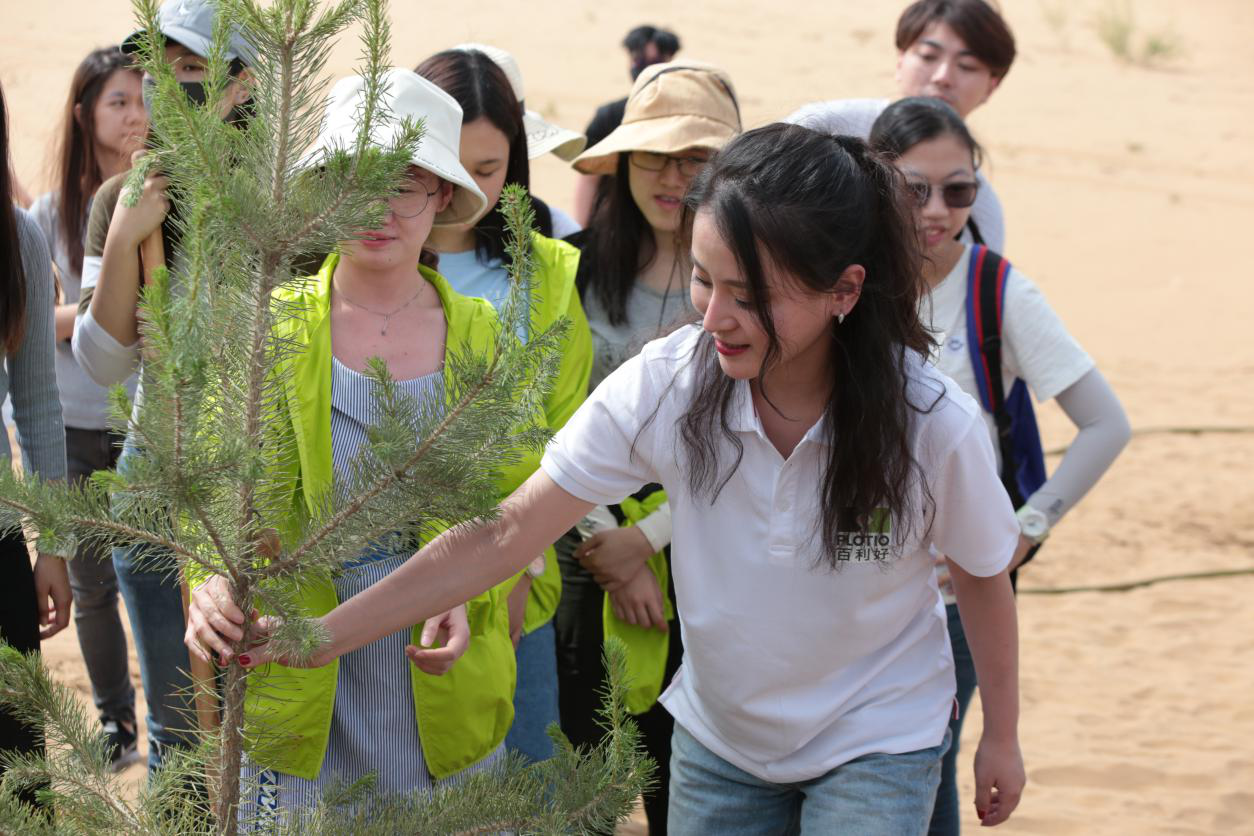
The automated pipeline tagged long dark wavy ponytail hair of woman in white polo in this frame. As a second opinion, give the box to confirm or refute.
[678,124,939,568]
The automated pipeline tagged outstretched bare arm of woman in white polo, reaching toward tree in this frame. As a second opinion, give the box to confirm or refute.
[320,471,592,661]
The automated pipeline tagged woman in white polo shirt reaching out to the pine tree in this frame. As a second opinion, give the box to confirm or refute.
[223,124,1025,836]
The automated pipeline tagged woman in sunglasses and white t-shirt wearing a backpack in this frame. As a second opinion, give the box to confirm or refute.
[870,97,1130,833]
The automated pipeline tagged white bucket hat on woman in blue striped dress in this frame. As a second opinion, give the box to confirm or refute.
[301,66,488,227]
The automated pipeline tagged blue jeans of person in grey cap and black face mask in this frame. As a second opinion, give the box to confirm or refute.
[113,446,196,770]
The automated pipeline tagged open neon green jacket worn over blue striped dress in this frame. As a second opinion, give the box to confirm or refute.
[246,254,514,780]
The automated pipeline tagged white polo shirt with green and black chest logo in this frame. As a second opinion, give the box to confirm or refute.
[540,326,1018,782]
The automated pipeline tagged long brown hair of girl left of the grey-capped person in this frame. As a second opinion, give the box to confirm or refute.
[54,46,139,272]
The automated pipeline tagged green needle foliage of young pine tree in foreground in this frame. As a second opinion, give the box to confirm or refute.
[0,0,651,835]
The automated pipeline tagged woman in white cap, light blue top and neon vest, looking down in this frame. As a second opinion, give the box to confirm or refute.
[418,45,592,761]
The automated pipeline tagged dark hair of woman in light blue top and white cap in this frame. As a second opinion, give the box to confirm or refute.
[414,49,553,262]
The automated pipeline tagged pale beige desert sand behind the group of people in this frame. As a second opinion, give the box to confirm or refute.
[0,0,1254,836]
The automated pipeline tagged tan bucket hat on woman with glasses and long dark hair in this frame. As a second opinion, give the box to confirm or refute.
[574,61,740,174]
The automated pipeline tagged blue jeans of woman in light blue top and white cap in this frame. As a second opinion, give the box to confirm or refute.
[505,620,558,761]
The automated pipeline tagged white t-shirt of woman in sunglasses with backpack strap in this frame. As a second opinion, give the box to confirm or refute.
[919,247,1093,468]
